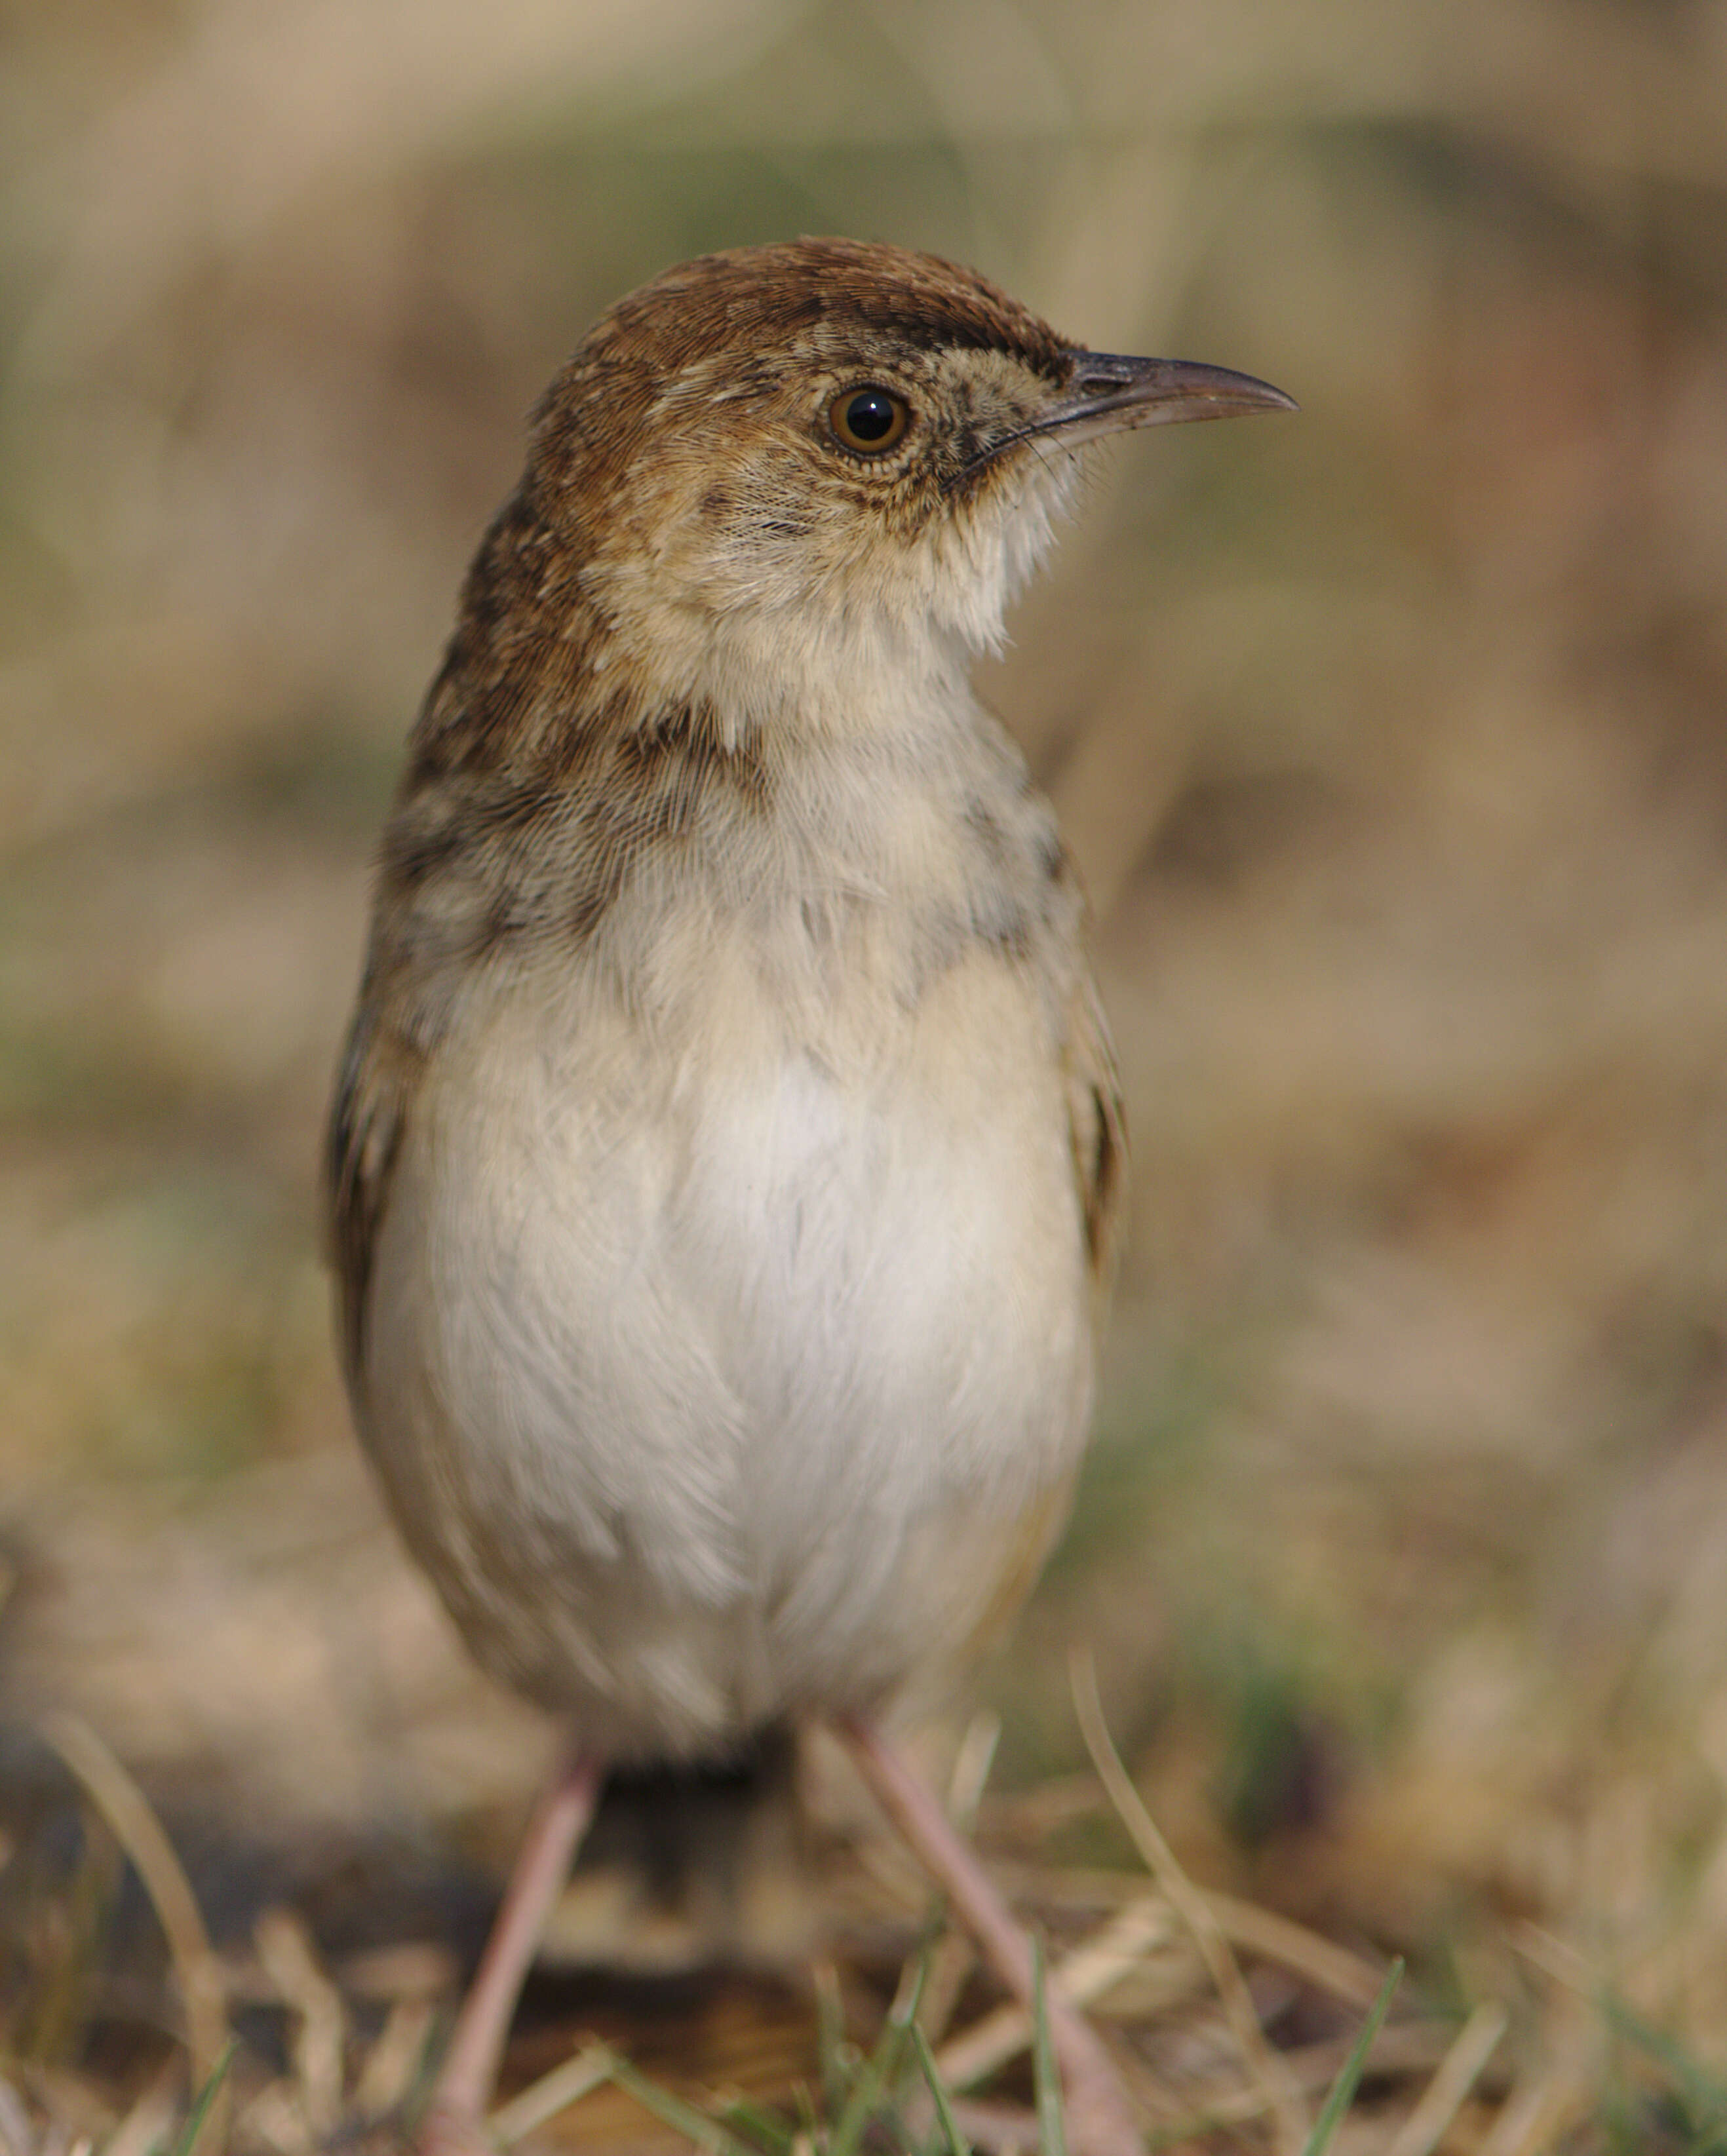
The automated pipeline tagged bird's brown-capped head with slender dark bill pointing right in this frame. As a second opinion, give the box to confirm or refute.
[472,239,1291,737]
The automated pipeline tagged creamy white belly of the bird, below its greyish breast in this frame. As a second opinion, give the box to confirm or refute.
[358,955,1091,1757]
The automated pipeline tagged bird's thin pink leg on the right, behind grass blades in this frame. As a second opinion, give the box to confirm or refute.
[839,1716,1145,2156]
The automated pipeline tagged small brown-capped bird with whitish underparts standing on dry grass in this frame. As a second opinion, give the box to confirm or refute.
[326,239,1294,2156]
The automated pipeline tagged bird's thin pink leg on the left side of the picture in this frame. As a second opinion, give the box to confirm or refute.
[416,1753,604,2156]
